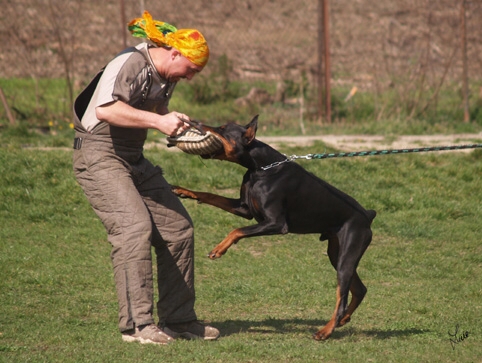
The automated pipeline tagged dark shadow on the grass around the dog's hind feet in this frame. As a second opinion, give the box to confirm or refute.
[211,318,428,340]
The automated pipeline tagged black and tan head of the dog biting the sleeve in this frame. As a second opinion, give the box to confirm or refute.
[194,115,258,164]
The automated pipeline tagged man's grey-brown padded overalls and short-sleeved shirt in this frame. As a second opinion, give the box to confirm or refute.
[73,46,196,332]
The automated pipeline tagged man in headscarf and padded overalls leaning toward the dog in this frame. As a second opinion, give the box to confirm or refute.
[73,12,219,344]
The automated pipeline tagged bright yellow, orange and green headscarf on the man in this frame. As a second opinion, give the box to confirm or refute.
[127,11,209,67]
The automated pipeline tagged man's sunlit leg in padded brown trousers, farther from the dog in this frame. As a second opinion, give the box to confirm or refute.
[74,147,154,331]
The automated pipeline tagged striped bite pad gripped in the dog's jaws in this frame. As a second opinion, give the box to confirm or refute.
[167,128,223,158]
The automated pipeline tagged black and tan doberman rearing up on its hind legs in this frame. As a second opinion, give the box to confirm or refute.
[172,116,376,340]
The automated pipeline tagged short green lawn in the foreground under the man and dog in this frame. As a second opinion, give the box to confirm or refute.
[0,130,482,363]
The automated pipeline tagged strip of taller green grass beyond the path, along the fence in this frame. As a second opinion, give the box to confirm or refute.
[0,77,482,135]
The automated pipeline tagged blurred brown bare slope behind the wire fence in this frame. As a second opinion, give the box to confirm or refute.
[0,0,482,121]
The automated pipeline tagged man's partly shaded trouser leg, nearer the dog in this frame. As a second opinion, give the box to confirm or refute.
[134,164,196,326]
